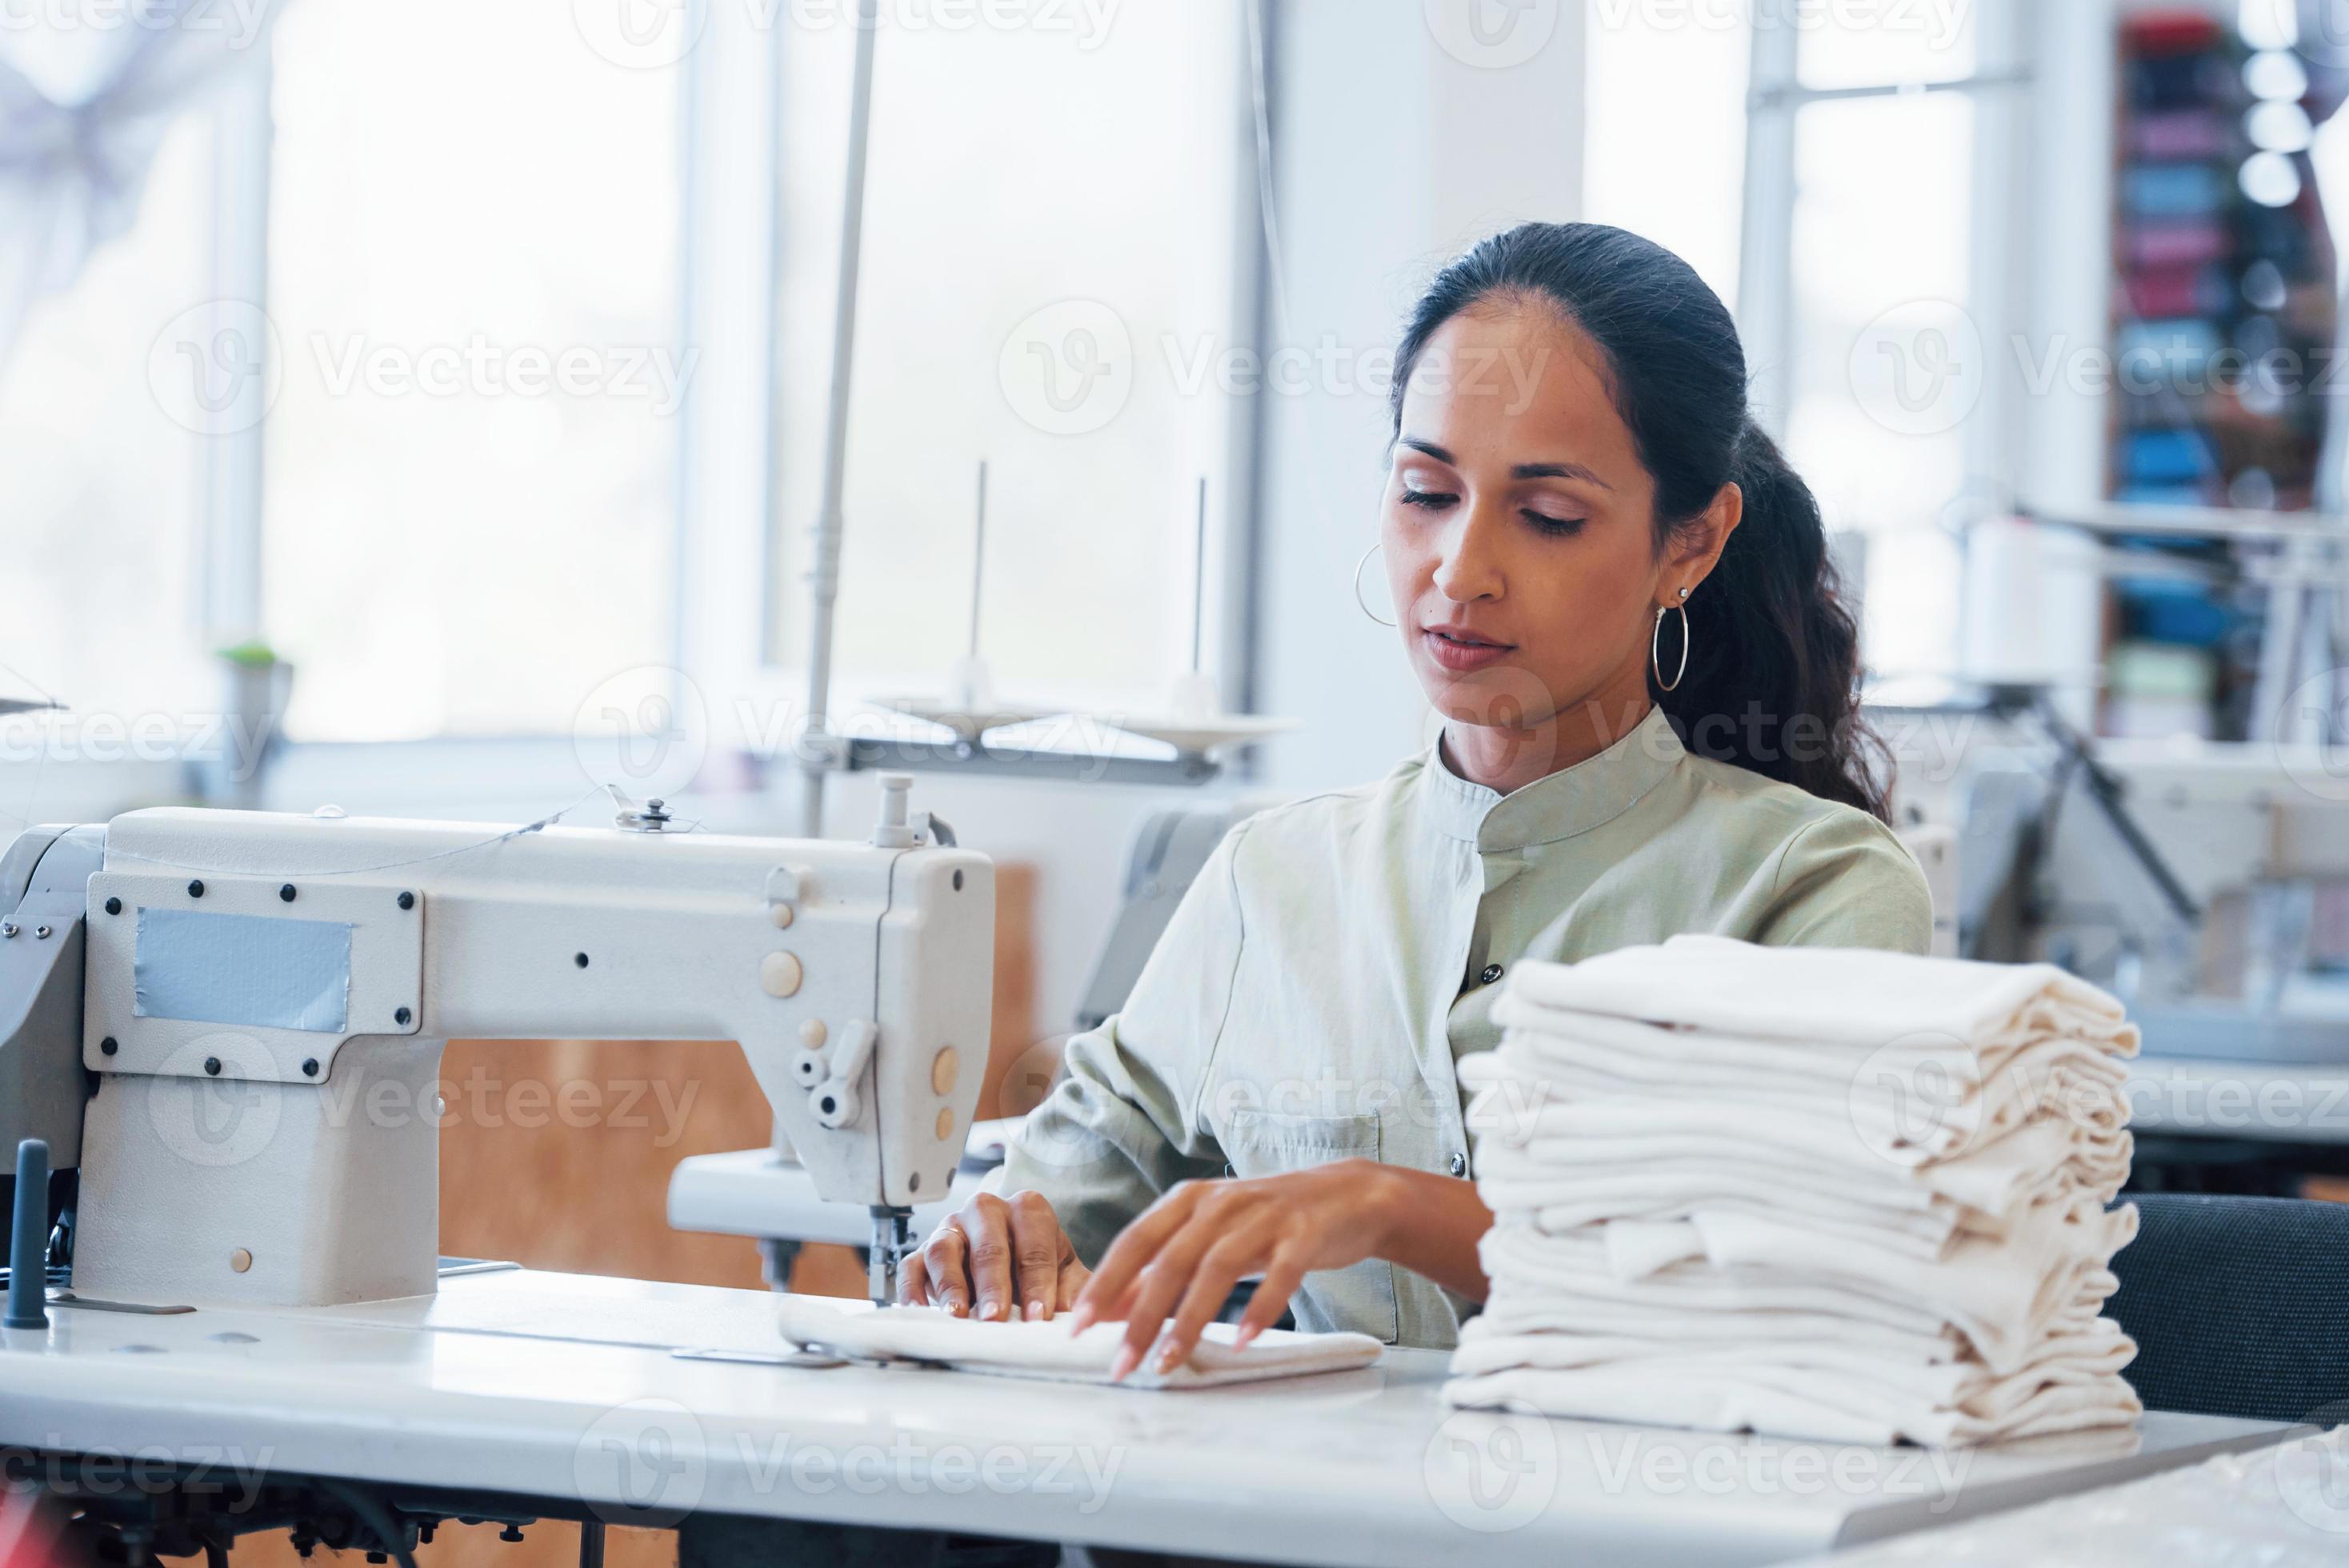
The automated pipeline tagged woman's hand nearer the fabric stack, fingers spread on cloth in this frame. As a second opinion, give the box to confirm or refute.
[1071,1159,1395,1382]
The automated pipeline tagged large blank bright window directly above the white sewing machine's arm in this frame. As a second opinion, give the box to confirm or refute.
[263,0,693,739]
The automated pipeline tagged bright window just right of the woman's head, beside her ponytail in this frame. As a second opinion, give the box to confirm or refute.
[1741,7,2018,674]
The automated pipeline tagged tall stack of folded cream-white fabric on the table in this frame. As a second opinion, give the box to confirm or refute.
[1445,937,2140,1443]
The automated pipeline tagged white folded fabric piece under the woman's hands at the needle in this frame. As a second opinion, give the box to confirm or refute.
[775,1296,1383,1390]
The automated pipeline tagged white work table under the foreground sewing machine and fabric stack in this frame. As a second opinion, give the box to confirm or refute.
[0,1270,2281,1566]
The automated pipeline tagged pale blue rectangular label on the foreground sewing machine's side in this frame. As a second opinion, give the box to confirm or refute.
[134,909,350,1033]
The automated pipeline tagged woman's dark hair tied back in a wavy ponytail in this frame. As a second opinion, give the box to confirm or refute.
[1391,223,1889,819]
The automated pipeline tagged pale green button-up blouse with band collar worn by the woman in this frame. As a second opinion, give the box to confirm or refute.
[989,711,1933,1347]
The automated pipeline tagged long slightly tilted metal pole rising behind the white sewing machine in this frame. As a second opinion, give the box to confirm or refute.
[801,0,881,838]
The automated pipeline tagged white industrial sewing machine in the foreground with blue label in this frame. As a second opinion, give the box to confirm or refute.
[0,774,994,1307]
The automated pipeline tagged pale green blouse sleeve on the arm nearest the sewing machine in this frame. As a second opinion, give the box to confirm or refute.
[986,822,1247,1263]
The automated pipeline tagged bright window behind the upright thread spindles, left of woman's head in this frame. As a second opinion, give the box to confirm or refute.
[770,0,1252,716]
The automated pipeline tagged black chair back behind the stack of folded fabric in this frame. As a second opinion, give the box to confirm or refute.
[2105,1193,2349,1425]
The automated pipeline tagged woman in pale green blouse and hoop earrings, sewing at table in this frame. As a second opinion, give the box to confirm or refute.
[904,223,1931,1378]
